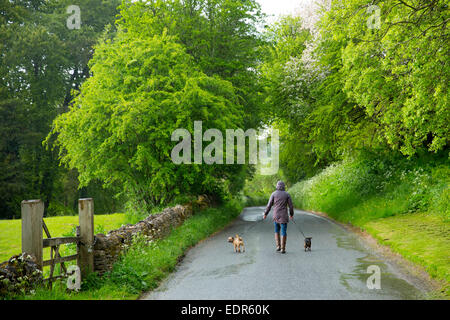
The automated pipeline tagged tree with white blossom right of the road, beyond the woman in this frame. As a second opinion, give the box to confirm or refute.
[260,16,328,183]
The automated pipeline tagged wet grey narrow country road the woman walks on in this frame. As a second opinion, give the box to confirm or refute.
[143,207,423,300]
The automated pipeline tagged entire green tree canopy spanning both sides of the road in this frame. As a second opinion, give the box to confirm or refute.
[0,0,450,217]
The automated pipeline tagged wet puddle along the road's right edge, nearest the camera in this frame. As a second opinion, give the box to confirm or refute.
[335,235,424,300]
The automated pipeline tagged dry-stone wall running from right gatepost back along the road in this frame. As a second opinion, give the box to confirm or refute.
[94,196,210,274]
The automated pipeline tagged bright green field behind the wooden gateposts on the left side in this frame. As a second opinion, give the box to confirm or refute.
[0,214,125,262]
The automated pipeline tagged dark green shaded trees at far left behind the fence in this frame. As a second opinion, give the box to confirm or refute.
[0,0,120,217]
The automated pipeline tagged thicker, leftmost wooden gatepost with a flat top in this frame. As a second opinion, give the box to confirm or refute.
[21,200,44,270]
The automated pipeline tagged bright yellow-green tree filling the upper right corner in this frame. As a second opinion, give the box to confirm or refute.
[320,0,450,156]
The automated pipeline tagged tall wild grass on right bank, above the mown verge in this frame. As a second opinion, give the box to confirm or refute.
[289,156,450,225]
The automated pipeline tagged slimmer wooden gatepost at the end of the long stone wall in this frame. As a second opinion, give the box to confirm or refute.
[78,198,94,277]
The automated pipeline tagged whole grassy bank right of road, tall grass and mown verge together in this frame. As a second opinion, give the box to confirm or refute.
[289,157,450,296]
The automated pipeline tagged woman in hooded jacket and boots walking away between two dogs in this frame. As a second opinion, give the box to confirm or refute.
[264,181,294,253]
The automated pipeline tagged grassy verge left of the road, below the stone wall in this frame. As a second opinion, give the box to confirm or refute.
[7,201,243,300]
